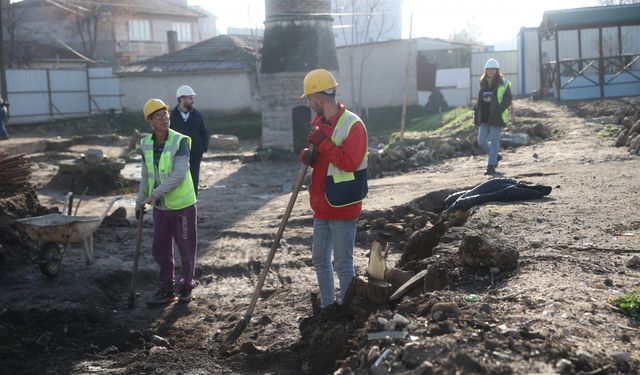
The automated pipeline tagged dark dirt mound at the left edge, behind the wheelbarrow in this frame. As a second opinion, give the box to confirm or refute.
[0,185,57,269]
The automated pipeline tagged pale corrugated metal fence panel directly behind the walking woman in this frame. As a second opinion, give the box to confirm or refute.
[471,50,520,99]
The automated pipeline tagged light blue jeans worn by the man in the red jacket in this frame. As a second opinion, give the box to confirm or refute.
[312,219,357,307]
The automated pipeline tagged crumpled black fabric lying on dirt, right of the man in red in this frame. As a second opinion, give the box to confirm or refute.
[444,178,551,210]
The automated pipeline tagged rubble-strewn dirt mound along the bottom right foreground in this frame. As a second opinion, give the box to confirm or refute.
[335,292,632,374]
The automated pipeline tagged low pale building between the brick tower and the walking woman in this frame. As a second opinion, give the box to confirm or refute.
[338,38,484,109]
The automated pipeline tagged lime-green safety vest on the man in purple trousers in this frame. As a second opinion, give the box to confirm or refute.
[140,129,196,210]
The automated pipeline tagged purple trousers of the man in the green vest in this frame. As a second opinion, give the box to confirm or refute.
[152,204,198,292]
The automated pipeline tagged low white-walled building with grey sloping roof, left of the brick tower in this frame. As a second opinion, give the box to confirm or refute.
[118,35,261,112]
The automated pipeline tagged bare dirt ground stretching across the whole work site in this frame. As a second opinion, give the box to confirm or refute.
[0,100,640,374]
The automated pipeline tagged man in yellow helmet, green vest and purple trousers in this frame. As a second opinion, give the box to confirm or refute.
[135,99,198,305]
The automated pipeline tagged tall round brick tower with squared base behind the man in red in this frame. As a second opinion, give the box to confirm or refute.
[259,0,338,150]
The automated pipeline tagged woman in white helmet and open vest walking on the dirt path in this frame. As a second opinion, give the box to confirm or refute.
[474,58,512,175]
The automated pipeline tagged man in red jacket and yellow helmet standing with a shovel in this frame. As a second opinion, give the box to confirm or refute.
[300,69,368,307]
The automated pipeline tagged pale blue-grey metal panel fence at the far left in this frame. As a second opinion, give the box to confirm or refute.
[6,68,122,122]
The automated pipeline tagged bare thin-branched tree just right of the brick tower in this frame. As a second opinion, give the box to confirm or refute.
[334,0,396,113]
